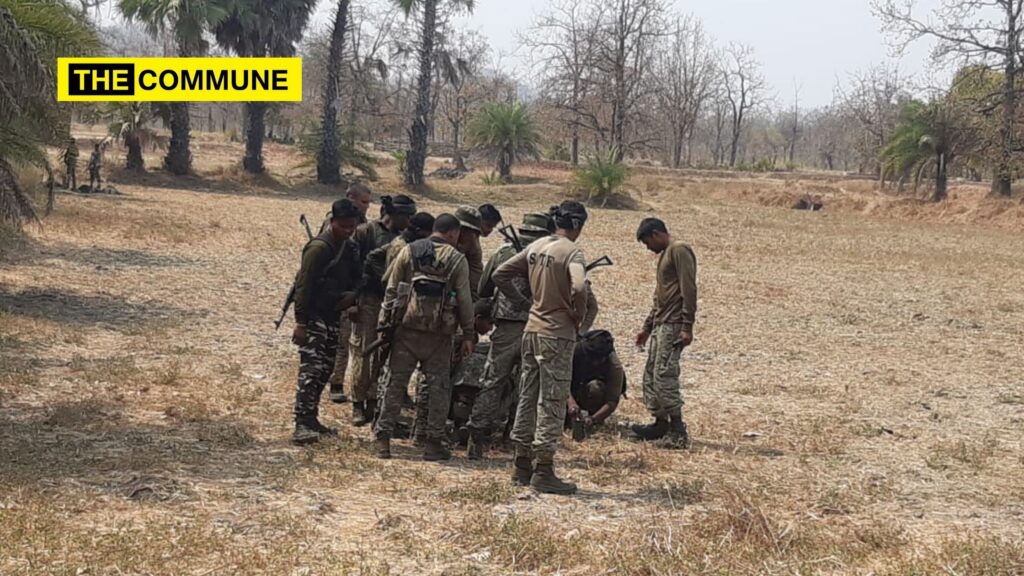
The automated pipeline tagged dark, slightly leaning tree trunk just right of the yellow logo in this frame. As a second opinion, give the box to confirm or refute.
[316,0,349,186]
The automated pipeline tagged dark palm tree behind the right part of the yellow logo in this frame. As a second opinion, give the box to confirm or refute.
[213,0,316,174]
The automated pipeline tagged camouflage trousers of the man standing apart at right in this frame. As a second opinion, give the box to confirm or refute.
[643,324,683,418]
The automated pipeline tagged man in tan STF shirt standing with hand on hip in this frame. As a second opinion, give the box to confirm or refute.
[494,200,589,494]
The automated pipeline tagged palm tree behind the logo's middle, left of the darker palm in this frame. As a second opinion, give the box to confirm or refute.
[118,0,230,175]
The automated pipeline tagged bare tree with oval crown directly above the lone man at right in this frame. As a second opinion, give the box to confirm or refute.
[652,15,718,168]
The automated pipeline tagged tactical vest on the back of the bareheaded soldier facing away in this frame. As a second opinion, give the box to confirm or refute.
[401,239,466,336]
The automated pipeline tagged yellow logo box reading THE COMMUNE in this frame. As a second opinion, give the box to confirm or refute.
[57,57,302,102]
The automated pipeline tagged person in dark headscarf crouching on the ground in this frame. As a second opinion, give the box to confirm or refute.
[565,330,626,430]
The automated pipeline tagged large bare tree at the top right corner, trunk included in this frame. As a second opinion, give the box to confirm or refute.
[873,0,1024,196]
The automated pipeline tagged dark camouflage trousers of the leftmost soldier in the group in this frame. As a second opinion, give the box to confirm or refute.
[295,320,338,422]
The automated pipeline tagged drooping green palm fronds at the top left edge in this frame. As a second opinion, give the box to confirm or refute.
[0,0,100,227]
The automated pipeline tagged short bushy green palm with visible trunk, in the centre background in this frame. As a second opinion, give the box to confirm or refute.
[466,102,541,182]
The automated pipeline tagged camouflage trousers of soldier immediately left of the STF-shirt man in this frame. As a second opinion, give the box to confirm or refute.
[469,320,526,435]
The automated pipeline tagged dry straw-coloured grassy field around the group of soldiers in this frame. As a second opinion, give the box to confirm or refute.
[0,132,1024,576]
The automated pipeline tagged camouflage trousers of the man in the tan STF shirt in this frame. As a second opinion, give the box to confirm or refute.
[512,332,575,452]
